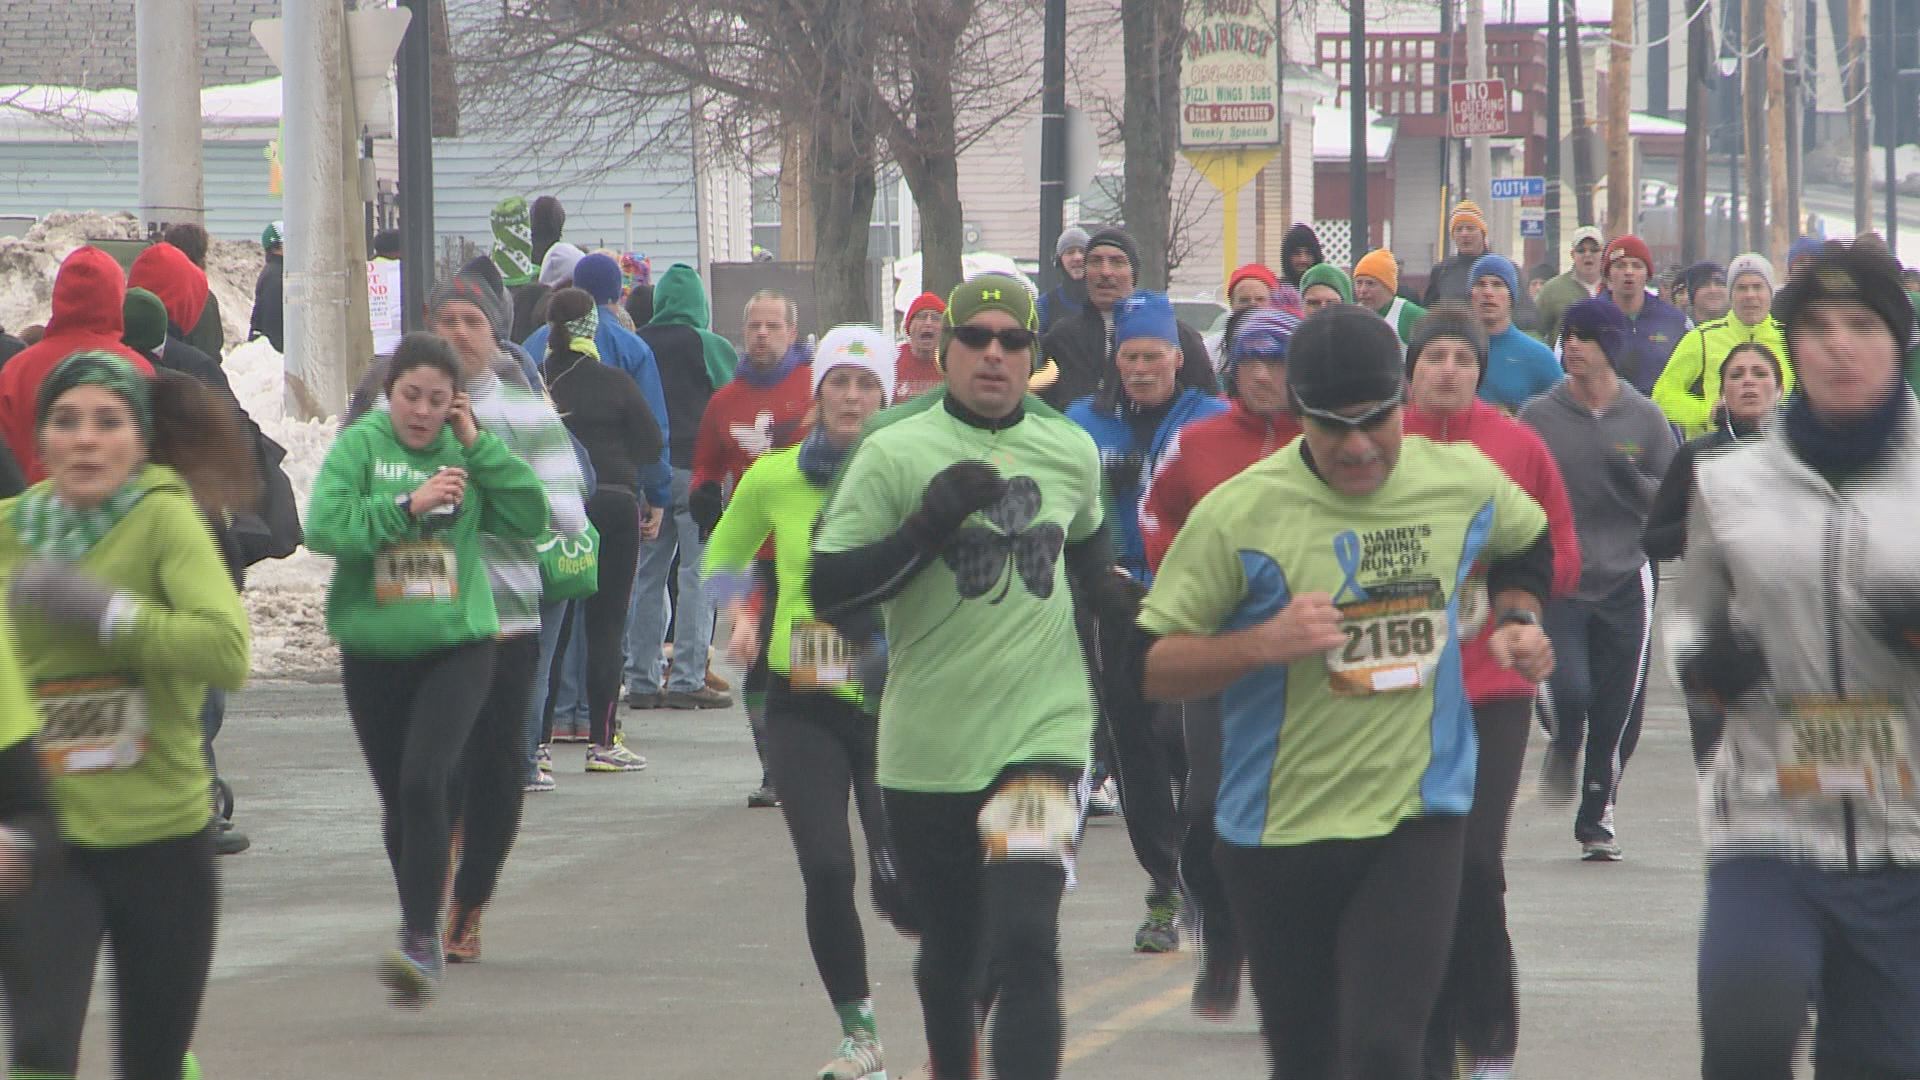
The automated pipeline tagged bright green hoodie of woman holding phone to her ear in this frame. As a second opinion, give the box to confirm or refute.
[307,409,547,659]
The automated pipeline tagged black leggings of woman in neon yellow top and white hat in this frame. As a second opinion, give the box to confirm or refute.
[766,673,900,1005]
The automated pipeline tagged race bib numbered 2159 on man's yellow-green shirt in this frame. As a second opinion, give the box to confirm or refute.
[1327,580,1450,698]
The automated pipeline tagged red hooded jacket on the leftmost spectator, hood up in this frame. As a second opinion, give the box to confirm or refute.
[0,248,153,484]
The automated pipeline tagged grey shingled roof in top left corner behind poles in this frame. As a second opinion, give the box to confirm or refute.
[0,0,280,90]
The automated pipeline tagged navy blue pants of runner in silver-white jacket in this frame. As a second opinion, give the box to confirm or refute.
[1699,857,1920,1080]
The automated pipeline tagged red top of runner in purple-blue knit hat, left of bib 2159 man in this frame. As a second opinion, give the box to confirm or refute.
[1140,400,1300,575]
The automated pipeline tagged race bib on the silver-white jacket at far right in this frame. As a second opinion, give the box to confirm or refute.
[1778,696,1914,803]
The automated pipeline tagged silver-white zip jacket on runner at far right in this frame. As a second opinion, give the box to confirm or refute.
[1667,386,1920,872]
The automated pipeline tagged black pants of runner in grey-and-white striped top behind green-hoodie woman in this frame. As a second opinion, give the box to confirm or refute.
[453,634,540,911]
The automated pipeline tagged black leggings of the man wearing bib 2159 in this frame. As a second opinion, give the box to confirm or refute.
[1217,817,1467,1080]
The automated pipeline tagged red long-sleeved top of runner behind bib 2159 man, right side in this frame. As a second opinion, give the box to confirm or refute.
[1405,398,1580,705]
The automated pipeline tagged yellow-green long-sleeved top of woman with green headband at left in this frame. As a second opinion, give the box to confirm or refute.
[0,465,248,847]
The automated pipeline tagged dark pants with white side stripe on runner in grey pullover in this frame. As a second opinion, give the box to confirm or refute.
[1544,565,1653,844]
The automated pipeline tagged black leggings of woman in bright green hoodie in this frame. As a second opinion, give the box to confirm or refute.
[340,642,495,936]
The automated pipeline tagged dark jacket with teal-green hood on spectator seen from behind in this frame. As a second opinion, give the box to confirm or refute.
[639,263,739,469]
